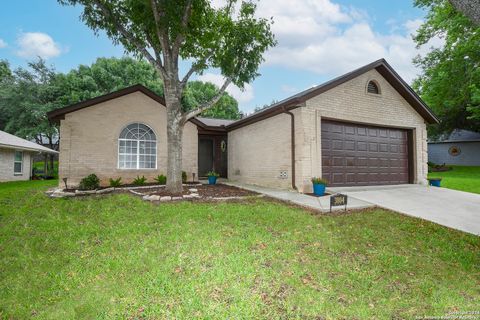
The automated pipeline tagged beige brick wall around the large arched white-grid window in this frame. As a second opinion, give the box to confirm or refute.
[59,92,198,186]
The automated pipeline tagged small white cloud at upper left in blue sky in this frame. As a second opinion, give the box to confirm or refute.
[17,32,62,59]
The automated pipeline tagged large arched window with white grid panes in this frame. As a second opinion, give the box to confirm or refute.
[118,123,157,169]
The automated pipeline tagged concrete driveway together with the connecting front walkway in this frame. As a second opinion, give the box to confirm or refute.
[226,181,480,235]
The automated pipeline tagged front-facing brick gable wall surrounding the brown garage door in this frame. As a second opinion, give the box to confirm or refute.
[296,70,428,192]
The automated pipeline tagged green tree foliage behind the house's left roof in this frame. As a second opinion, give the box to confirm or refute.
[0,57,241,149]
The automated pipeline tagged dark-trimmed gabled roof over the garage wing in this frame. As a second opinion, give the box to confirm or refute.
[227,59,439,130]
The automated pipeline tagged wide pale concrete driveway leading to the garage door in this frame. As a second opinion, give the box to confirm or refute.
[329,185,480,235]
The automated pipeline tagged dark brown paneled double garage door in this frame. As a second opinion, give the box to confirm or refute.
[322,120,409,186]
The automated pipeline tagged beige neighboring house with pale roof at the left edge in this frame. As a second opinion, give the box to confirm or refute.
[0,131,58,182]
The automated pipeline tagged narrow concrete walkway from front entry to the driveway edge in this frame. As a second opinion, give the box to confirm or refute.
[222,181,375,212]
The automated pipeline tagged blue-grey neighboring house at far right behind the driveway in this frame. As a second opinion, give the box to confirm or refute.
[428,129,480,166]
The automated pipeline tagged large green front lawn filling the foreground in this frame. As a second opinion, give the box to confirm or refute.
[0,181,480,319]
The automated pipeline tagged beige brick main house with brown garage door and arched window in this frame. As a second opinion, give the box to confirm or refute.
[49,59,438,192]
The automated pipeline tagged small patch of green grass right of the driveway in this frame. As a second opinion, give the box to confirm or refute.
[428,166,480,193]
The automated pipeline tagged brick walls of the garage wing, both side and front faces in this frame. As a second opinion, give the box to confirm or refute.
[228,70,428,192]
